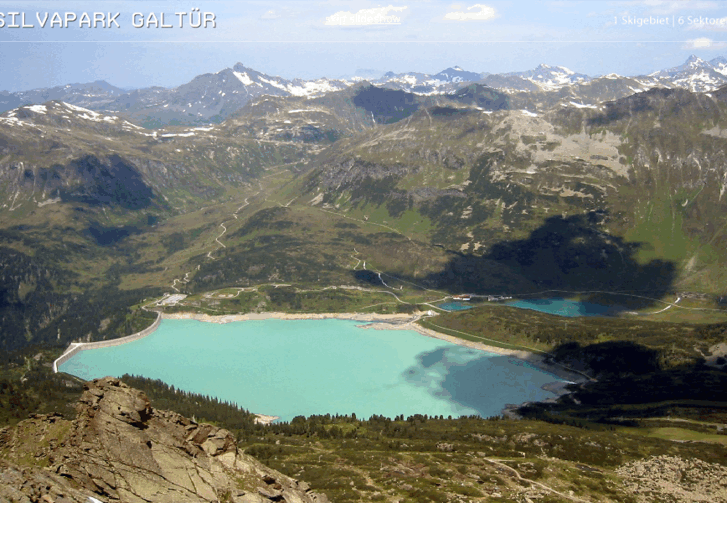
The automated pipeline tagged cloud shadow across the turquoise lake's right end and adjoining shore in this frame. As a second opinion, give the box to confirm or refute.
[402,342,727,422]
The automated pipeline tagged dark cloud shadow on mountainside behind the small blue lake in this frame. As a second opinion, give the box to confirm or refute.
[352,212,677,309]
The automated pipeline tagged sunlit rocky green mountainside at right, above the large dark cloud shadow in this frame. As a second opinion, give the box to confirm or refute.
[280,93,727,302]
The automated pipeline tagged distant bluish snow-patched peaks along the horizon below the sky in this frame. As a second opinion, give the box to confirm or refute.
[0,55,727,128]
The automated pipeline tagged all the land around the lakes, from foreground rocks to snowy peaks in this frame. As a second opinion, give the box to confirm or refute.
[0,56,727,501]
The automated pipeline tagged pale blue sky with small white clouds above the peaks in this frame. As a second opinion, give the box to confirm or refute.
[0,0,727,91]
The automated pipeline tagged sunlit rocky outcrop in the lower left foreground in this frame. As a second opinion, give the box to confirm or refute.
[0,377,326,503]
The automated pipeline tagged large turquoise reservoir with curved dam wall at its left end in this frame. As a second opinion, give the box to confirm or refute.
[60,320,559,421]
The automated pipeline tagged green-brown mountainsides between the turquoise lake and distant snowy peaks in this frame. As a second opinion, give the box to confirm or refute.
[0,72,727,348]
